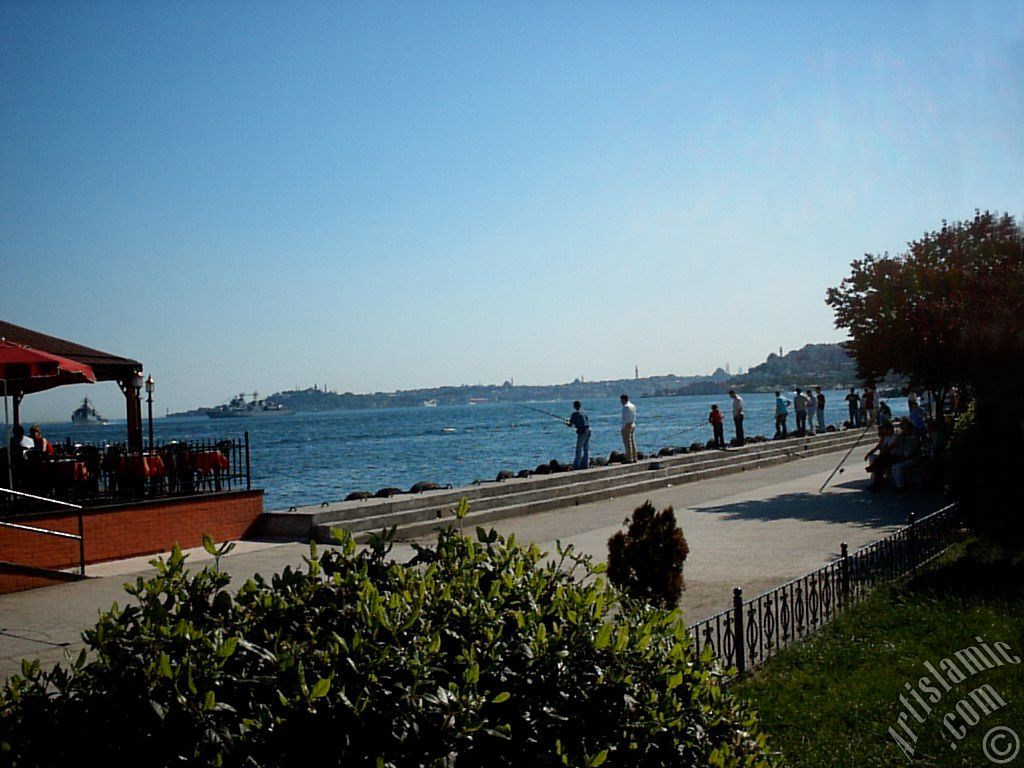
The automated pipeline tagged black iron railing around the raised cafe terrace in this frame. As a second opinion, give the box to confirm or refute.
[0,432,252,516]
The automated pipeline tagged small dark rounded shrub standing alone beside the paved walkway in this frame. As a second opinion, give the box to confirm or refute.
[608,501,690,609]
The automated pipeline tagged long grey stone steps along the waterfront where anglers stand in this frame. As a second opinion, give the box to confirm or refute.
[310,431,860,542]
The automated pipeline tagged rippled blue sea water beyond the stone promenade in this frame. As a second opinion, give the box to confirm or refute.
[43,391,906,510]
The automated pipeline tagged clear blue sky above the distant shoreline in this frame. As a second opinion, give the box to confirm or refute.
[0,0,1024,420]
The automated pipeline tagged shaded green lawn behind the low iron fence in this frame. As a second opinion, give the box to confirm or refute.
[734,540,1024,768]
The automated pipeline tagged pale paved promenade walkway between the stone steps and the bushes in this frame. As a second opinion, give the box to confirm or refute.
[0,447,941,679]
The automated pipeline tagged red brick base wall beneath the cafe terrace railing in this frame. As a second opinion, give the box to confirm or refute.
[0,490,263,593]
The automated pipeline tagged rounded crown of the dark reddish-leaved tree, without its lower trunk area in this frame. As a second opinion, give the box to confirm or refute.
[826,211,1024,411]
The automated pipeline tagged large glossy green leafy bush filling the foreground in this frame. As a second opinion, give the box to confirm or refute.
[0,507,776,768]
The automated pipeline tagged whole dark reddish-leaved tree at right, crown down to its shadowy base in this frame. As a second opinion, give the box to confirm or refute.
[826,211,1024,544]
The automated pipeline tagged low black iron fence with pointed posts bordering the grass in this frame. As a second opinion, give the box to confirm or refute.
[689,504,959,674]
